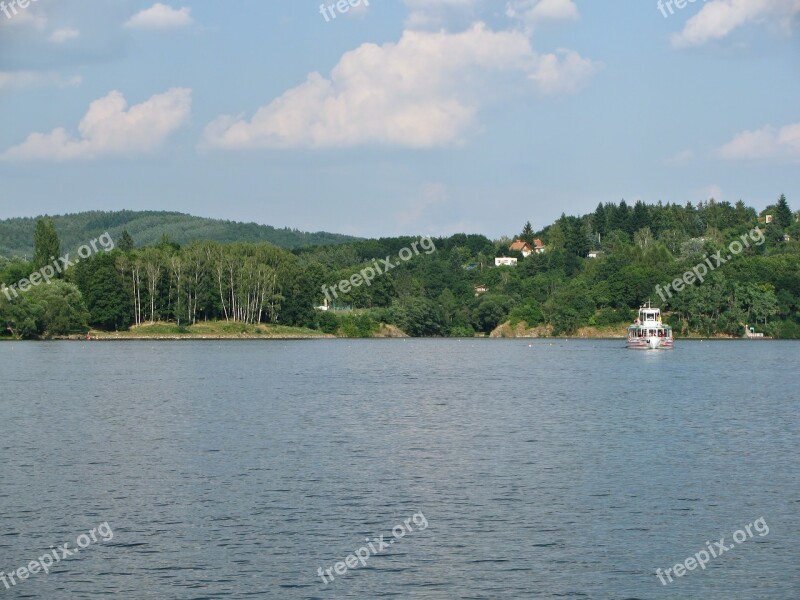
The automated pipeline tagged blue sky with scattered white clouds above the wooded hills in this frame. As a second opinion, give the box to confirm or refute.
[0,0,800,238]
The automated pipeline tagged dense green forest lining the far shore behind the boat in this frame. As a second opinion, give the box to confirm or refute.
[0,196,800,338]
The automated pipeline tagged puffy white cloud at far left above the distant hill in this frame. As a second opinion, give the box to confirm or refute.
[0,88,192,161]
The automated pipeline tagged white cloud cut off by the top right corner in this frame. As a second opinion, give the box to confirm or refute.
[672,0,800,48]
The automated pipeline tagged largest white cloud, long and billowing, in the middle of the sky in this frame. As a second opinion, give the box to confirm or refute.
[205,23,597,149]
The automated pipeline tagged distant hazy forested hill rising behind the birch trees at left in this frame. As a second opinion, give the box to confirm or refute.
[0,210,357,257]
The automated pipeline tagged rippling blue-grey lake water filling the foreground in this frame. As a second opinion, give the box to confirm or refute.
[0,340,800,600]
